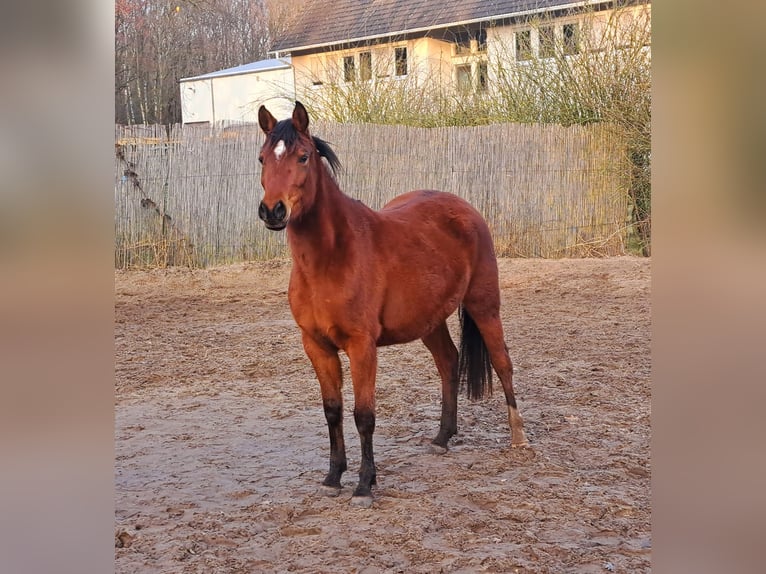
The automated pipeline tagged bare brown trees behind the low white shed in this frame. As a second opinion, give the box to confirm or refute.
[115,0,296,124]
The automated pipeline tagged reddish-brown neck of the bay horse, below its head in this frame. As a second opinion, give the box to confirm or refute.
[288,174,373,262]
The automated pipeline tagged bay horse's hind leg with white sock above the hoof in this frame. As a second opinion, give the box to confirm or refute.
[463,302,529,447]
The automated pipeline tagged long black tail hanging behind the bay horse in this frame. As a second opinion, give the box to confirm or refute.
[458,306,492,400]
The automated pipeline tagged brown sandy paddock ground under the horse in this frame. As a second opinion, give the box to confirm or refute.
[115,257,651,574]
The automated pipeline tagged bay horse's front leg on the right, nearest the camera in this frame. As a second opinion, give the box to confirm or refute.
[346,338,378,508]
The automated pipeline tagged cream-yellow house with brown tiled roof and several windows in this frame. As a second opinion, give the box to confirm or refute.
[271,0,651,115]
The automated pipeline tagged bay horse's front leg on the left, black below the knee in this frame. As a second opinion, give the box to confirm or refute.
[303,333,347,496]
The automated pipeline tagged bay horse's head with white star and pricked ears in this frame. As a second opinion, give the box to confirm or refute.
[258,102,339,231]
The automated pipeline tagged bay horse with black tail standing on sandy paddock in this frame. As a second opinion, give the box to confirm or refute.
[258,102,528,507]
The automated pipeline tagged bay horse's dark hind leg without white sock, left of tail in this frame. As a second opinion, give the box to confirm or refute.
[422,322,458,453]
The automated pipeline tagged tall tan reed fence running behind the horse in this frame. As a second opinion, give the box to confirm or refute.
[115,121,631,268]
